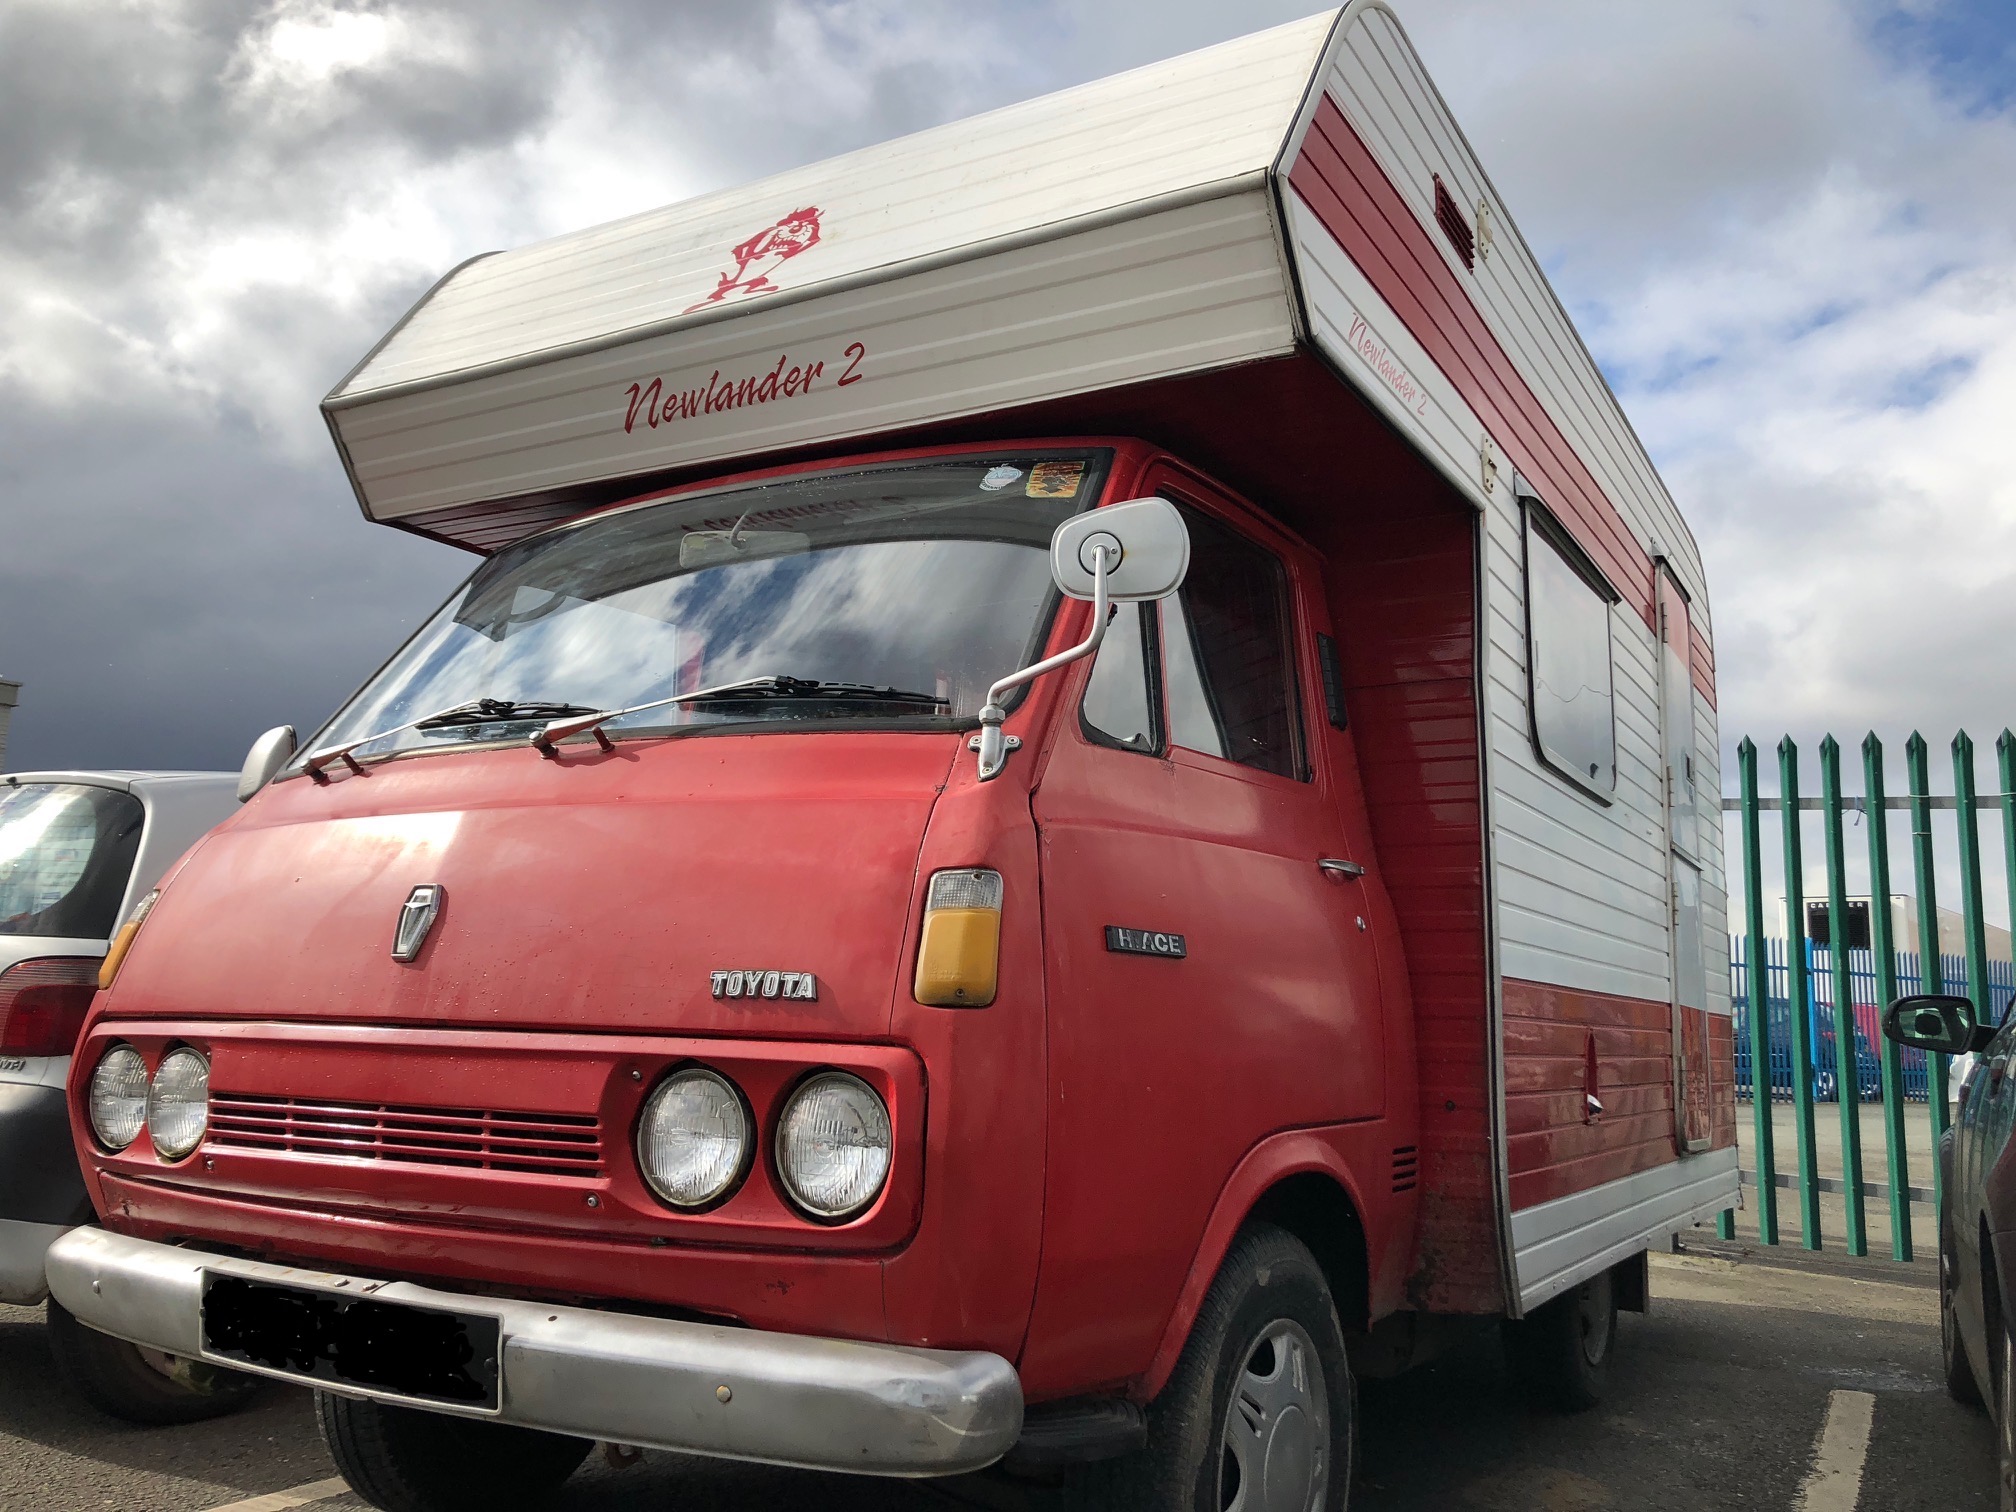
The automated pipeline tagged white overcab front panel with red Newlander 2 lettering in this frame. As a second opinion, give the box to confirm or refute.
[333,195,1294,520]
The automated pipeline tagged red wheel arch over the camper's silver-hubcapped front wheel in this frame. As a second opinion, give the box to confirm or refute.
[1139,1129,1371,1401]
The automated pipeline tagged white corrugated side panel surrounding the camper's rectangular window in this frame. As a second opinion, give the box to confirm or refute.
[1484,488,1671,1002]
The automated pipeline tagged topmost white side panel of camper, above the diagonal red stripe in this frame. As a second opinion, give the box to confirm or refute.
[1329,6,1708,608]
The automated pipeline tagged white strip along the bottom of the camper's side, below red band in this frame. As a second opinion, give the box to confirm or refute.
[1512,1149,1738,1312]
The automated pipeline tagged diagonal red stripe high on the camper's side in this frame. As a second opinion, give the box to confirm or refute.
[1288,95,1653,625]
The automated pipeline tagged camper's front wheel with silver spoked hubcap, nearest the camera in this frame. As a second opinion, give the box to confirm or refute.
[1079,1224,1357,1512]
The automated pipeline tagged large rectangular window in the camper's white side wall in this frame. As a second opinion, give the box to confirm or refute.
[1526,510,1617,796]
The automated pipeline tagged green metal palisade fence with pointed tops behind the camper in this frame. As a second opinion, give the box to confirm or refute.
[1720,730,2016,1260]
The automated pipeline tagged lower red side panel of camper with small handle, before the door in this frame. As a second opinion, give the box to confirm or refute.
[1504,978,1677,1212]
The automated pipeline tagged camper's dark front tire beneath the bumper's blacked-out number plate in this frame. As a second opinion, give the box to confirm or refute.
[314,1391,595,1512]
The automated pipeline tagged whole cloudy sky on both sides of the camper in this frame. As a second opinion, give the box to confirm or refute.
[0,0,2016,842]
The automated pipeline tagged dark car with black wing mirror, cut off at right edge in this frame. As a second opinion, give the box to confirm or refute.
[1883,996,2016,1512]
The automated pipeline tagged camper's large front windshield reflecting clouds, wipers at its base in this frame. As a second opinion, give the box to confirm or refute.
[304,450,1105,758]
